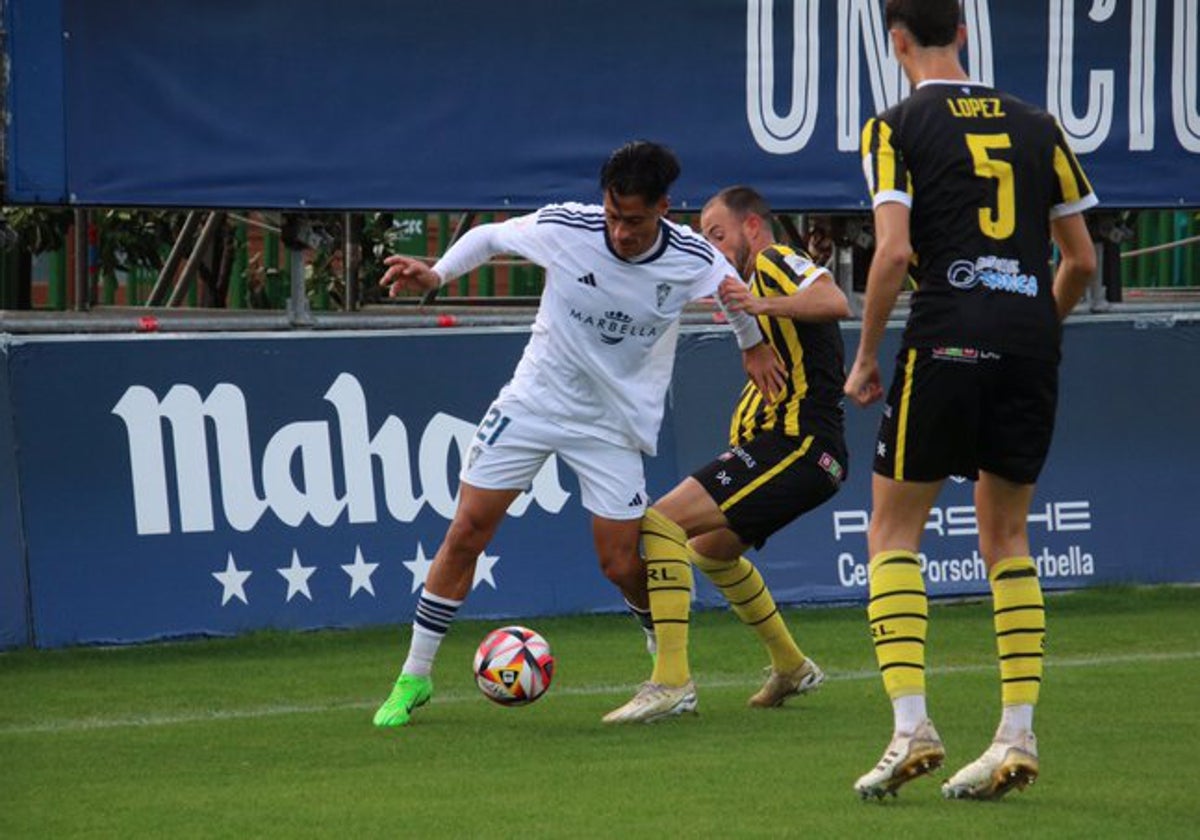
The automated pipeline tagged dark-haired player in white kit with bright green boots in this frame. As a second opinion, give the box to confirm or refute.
[374,140,784,726]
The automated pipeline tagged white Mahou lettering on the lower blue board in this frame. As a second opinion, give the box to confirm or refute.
[112,372,570,535]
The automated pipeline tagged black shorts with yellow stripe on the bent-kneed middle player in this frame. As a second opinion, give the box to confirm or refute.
[692,431,848,548]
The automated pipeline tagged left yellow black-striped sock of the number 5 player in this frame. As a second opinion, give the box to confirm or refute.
[866,551,929,700]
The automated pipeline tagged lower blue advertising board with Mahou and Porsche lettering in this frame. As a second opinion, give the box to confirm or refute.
[0,319,1200,647]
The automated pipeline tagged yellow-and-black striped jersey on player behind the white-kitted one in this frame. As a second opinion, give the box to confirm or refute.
[730,245,846,446]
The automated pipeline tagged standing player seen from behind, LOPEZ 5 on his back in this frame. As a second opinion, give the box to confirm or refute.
[845,0,1097,799]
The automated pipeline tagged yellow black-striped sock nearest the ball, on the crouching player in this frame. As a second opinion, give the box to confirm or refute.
[642,508,691,685]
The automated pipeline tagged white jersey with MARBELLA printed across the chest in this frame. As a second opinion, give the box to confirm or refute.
[433,203,761,455]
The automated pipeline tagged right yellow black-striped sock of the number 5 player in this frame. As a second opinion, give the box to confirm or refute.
[988,557,1046,706]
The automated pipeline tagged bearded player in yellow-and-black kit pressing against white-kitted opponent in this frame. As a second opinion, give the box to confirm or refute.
[605,186,850,722]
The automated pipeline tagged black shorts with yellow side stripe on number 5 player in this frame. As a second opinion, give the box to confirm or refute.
[875,347,1058,484]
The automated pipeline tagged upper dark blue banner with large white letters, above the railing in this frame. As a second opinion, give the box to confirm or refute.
[6,0,1200,211]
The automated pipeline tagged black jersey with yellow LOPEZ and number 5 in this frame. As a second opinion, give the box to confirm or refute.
[862,82,1097,360]
